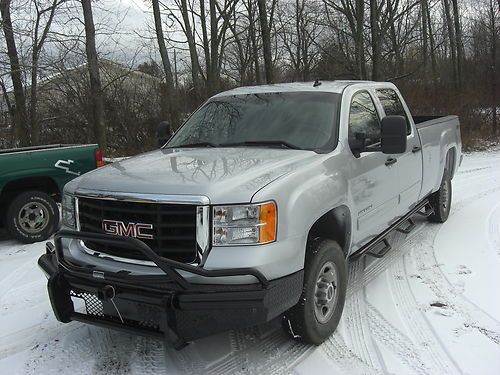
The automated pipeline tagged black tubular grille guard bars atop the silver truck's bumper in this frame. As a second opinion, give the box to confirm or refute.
[51,229,269,290]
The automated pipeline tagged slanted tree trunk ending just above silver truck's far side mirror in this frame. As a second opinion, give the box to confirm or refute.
[152,0,179,129]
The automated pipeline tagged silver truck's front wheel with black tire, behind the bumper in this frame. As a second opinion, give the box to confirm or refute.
[284,239,347,345]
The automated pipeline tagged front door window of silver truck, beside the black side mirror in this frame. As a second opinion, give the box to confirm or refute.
[349,91,381,150]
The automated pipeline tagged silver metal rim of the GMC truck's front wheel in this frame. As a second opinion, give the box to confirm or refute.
[314,262,338,324]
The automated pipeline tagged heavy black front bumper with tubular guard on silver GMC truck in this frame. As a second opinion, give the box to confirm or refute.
[38,231,303,348]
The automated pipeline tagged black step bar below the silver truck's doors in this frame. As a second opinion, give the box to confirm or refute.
[349,198,434,260]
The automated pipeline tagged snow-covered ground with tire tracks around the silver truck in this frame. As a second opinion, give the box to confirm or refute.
[0,152,500,375]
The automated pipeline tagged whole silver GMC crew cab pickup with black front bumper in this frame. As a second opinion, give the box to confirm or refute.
[39,81,462,348]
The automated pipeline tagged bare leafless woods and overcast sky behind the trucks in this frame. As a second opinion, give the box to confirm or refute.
[0,0,500,155]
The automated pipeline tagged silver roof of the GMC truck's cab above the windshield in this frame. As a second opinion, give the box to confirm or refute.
[214,80,391,97]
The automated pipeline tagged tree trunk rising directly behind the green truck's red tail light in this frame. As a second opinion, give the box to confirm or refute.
[82,0,107,150]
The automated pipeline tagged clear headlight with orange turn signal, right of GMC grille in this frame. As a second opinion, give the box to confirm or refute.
[212,202,277,246]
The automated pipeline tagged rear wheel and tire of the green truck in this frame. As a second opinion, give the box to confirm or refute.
[6,190,59,243]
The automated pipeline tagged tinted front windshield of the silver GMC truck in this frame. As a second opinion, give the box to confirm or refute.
[166,92,340,151]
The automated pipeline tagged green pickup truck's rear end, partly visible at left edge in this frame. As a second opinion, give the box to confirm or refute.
[0,144,104,243]
